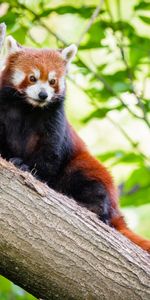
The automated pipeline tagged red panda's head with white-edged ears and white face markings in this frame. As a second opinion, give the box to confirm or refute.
[1,36,77,107]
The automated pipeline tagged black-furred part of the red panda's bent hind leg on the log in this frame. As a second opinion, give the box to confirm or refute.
[61,169,111,225]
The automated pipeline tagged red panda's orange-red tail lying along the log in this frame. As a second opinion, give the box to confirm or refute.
[111,216,150,253]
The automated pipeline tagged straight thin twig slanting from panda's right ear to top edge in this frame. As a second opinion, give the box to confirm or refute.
[76,0,104,47]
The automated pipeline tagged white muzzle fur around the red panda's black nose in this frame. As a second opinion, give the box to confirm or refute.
[26,80,55,106]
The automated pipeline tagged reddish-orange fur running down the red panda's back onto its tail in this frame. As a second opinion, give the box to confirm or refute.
[68,127,150,252]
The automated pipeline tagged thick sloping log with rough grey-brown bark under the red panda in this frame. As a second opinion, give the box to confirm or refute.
[0,159,150,300]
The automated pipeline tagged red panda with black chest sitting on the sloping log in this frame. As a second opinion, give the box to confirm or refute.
[0,37,150,252]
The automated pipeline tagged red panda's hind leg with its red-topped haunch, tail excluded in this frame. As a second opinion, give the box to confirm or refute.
[60,151,117,224]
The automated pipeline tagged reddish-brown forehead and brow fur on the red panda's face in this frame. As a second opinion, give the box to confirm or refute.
[1,48,65,92]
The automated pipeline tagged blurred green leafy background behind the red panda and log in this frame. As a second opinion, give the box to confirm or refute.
[0,0,150,300]
